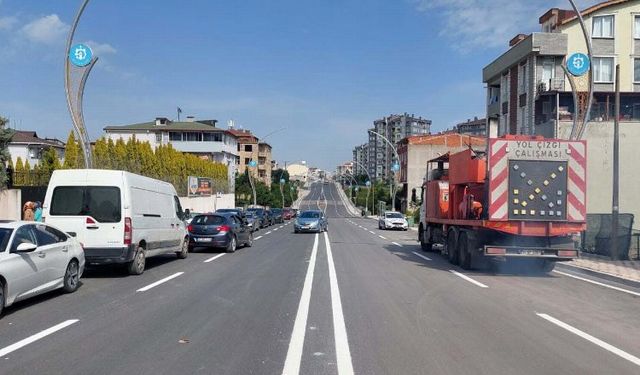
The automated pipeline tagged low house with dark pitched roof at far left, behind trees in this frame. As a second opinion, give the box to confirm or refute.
[8,130,65,167]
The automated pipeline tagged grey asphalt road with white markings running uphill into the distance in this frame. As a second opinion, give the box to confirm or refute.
[0,183,640,375]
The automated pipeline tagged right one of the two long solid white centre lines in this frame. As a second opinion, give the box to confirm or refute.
[324,232,353,375]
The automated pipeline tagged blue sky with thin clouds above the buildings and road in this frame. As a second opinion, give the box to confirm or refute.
[0,0,595,169]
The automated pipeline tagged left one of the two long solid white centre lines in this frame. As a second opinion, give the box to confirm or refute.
[282,234,318,375]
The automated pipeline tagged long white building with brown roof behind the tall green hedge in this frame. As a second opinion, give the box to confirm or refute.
[104,117,238,191]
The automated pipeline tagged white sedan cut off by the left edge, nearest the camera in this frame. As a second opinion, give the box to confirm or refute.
[0,221,85,314]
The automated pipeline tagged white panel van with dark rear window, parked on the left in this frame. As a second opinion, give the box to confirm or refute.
[42,169,189,275]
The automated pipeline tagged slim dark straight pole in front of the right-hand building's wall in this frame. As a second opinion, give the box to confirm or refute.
[611,64,620,260]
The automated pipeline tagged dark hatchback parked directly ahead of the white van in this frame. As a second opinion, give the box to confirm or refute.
[188,212,253,253]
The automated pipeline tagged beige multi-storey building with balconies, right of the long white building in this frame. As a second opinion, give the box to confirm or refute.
[229,129,273,186]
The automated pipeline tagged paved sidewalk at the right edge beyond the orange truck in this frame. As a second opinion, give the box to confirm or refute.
[561,253,640,283]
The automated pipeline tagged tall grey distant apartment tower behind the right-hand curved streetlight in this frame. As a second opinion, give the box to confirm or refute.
[367,113,431,179]
